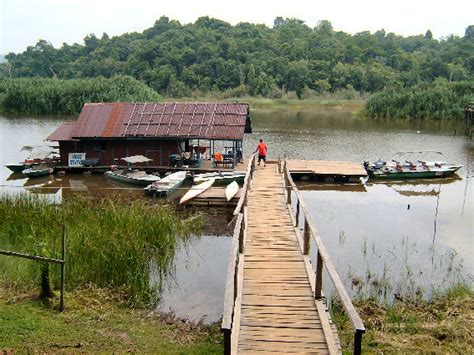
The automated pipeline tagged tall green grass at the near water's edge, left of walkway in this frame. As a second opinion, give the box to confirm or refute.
[0,196,200,305]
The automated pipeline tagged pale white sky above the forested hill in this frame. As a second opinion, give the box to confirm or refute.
[0,0,474,54]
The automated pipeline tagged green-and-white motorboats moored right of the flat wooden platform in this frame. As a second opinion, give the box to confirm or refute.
[364,151,462,179]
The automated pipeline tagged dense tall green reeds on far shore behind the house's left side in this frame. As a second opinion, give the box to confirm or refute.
[0,76,160,115]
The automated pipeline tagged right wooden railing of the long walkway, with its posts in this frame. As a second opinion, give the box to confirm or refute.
[279,159,365,354]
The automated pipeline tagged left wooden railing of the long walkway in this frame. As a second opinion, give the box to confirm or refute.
[221,154,256,354]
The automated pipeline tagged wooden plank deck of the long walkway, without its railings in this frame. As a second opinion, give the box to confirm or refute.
[233,164,335,353]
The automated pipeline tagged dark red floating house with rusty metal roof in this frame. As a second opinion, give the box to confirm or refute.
[47,102,252,166]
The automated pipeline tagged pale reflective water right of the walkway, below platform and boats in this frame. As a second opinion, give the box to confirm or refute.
[302,179,474,301]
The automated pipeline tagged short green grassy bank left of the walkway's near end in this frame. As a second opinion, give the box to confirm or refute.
[0,284,223,354]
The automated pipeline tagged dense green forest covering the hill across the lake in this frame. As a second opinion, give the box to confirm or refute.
[0,17,474,117]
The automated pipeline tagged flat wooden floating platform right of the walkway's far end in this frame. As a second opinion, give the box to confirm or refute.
[287,160,367,182]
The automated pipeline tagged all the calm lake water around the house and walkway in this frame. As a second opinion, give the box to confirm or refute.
[0,107,474,322]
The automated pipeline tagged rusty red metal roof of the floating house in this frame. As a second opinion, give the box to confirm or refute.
[48,102,250,141]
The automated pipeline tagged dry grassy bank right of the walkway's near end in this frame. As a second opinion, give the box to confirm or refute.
[333,285,474,354]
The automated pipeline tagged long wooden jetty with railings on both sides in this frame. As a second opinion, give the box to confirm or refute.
[221,157,365,354]
